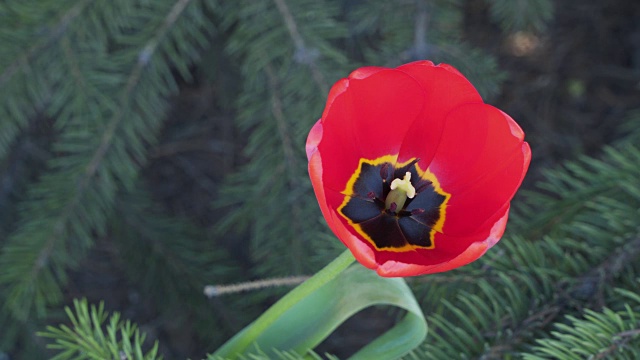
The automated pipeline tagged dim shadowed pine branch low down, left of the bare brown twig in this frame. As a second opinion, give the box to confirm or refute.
[109,184,244,346]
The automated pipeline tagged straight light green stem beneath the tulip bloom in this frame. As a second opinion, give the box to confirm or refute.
[213,250,355,358]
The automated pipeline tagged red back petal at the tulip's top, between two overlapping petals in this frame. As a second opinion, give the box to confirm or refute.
[398,61,482,169]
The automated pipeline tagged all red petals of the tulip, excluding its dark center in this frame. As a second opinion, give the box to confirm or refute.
[306,61,531,276]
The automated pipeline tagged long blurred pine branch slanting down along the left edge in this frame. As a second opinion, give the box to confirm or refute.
[0,1,215,318]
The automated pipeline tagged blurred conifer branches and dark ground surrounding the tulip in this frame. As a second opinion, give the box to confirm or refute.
[0,0,640,360]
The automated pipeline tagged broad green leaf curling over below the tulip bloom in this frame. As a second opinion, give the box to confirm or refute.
[214,264,427,359]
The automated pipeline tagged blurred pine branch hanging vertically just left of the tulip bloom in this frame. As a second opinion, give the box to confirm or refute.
[216,1,344,276]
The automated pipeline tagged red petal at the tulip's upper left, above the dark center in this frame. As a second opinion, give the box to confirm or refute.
[318,68,424,191]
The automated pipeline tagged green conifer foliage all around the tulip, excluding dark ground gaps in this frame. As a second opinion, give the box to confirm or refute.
[0,0,640,359]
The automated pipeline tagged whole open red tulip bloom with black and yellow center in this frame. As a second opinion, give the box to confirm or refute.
[306,61,531,277]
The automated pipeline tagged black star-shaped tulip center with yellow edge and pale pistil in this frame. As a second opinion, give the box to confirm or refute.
[338,157,449,251]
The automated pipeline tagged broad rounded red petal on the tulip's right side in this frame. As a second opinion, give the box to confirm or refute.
[429,104,531,236]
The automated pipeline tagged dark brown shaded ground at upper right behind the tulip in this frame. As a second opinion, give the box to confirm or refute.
[478,0,640,180]
